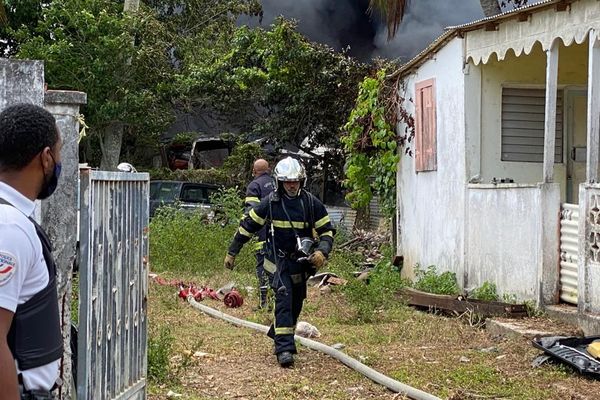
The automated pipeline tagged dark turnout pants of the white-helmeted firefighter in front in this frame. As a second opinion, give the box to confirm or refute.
[267,258,307,354]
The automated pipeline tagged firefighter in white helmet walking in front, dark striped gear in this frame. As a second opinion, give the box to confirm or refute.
[225,157,335,367]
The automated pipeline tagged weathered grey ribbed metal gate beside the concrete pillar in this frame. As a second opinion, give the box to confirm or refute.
[77,169,149,400]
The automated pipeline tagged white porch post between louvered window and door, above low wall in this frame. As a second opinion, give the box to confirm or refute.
[543,40,558,183]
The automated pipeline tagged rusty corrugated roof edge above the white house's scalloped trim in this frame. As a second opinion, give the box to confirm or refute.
[392,0,565,76]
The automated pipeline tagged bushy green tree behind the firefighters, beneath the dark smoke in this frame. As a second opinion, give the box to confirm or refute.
[180,19,368,181]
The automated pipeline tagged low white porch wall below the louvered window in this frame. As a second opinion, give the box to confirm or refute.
[466,184,560,302]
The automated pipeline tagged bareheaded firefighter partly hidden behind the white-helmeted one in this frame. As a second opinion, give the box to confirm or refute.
[244,158,274,308]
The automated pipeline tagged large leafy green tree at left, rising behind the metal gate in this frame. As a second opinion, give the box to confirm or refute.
[16,0,256,170]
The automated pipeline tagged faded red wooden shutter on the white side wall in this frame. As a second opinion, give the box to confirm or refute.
[415,79,437,172]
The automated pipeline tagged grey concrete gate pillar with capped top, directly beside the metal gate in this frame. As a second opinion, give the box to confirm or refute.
[41,90,86,399]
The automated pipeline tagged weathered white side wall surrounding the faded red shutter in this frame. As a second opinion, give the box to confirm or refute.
[397,39,466,277]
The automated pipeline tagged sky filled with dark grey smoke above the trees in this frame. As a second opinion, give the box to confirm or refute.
[241,0,492,61]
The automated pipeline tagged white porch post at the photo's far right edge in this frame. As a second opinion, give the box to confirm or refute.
[586,29,600,183]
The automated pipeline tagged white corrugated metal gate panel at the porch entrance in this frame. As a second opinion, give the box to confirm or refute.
[560,203,579,304]
